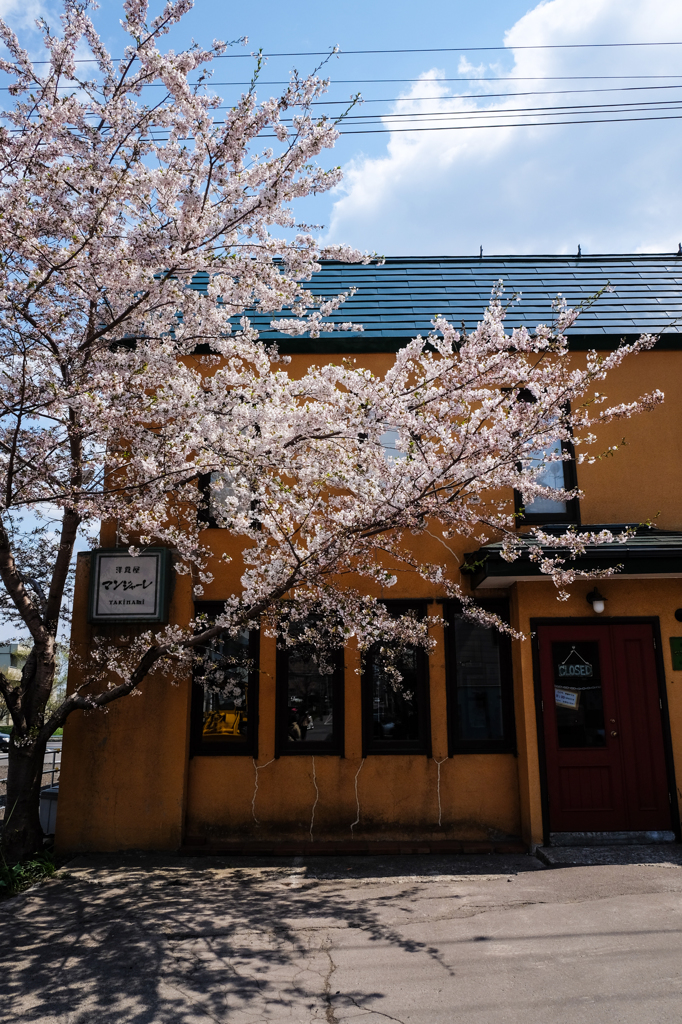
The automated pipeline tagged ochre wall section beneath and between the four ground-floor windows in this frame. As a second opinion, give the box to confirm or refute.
[186,630,520,842]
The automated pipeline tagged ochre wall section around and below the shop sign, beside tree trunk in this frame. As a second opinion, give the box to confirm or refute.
[55,554,191,851]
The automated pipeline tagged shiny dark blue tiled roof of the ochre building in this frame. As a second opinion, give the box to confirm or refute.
[191,254,682,351]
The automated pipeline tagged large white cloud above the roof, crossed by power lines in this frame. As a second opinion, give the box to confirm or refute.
[329,0,682,254]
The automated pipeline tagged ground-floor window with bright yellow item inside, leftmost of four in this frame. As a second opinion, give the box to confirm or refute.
[190,604,259,757]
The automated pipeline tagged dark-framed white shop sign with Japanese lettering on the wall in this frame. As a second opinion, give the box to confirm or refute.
[88,548,170,623]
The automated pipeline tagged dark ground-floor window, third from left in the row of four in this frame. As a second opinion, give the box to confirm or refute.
[363,601,431,756]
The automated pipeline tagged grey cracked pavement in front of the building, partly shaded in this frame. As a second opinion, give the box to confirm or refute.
[0,847,682,1024]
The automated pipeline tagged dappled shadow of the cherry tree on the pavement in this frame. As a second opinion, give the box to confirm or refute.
[0,856,537,1024]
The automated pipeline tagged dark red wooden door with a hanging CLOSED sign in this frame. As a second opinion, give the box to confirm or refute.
[538,624,671,831]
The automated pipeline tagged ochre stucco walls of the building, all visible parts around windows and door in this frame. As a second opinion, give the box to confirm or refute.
[56,351,682,850]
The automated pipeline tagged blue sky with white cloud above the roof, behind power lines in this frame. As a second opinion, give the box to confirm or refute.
[5,0,682,255]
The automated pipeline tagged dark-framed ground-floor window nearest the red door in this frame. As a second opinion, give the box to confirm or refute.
[445,601,516,754]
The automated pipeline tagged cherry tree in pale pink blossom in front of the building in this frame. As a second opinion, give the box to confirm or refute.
[0,0,663,858]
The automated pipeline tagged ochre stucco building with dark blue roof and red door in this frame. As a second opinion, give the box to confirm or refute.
[56,256,682,852]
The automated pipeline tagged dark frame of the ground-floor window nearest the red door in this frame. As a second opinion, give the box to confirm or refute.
[443,598,517,757]
